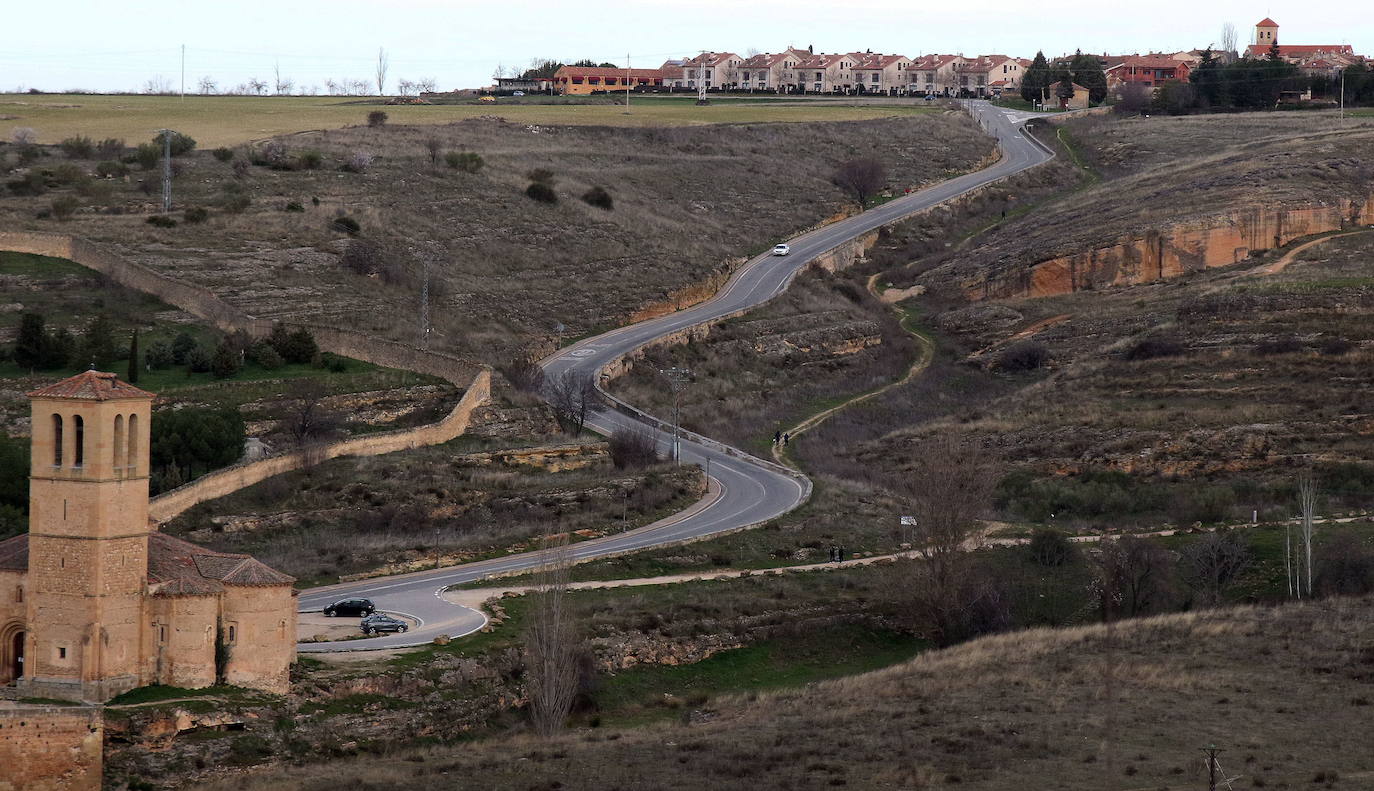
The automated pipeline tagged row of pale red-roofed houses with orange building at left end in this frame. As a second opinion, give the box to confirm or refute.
[548,48,1031,98]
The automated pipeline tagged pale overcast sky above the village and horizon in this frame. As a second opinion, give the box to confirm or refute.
[0,0,1374,92]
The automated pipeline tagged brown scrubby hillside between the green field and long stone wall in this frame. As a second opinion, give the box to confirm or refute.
[0,110,992,363]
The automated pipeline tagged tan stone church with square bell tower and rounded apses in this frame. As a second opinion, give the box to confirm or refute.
[0,371,295,702]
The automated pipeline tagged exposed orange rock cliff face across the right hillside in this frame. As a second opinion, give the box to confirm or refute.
[965,198,1374,299]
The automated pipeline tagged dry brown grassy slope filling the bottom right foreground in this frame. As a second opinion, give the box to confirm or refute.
[193,599,1374,791]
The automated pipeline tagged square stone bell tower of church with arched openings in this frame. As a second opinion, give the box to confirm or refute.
[19,371,154,700]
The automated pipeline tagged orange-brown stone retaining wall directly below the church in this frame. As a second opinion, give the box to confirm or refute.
[0,703,104,791]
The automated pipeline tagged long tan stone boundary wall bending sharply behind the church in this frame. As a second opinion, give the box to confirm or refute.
[0,231,491,522]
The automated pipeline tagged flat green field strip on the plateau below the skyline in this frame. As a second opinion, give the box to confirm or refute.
[0,93,934,148]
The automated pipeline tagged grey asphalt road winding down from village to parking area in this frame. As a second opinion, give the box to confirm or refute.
[298,102,1052,652]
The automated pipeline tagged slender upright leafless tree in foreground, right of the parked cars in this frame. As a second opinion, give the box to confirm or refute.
[525,536,581,739]
